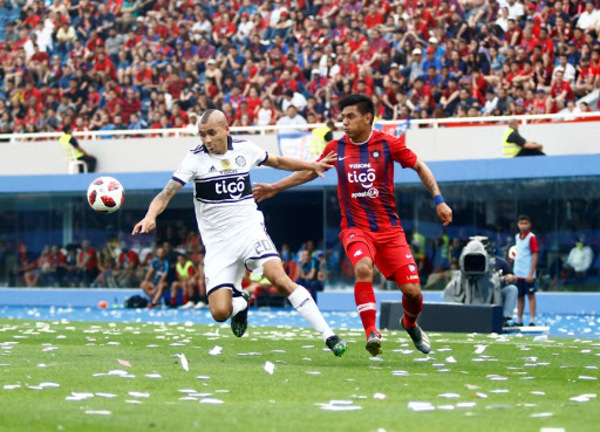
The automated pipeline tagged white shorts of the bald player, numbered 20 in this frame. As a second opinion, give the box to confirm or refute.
[204,222,281,296]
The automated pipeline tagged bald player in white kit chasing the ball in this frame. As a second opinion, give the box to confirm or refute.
[133,110,347,356]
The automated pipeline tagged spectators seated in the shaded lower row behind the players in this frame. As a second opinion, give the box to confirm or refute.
[0,221,600,305]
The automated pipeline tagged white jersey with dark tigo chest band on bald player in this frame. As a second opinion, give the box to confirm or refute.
[173,137,269,249]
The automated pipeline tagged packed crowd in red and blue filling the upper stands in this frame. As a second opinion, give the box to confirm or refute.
[0,0,600,137]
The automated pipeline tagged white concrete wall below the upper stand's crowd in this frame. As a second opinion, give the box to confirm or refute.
[0,122,600,175]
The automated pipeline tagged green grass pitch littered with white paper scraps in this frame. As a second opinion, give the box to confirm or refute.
[0,320,600,432]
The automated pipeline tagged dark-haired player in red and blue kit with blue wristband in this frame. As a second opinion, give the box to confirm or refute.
[254,95,452,355]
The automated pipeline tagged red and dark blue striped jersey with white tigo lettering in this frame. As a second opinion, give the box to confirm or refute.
[320,131,417,232]
